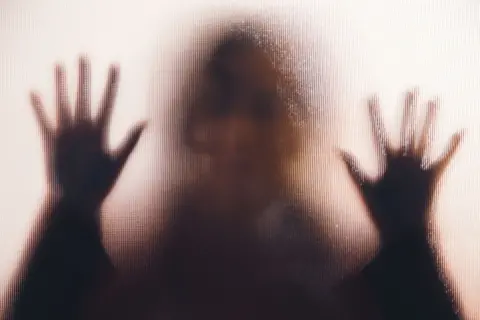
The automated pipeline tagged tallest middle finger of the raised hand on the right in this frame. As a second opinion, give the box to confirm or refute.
[400,90,418,154]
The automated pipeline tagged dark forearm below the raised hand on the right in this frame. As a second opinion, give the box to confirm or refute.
[364,232,459,319]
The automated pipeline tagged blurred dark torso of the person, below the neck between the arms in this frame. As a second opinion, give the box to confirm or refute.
[84,188,375,319]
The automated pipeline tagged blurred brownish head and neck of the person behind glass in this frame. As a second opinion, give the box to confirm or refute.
[180,23,303,220]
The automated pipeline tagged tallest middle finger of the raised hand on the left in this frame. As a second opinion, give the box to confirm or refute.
[75,57,90,122]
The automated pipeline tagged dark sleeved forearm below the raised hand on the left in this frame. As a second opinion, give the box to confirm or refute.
[10,198,111,320]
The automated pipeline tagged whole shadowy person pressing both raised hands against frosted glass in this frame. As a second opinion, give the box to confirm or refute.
[5,21,461,319]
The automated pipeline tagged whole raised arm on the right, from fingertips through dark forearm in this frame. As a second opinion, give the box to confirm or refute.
[342,91,463,319]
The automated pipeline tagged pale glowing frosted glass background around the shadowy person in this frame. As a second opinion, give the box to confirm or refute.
[0,0,480,319]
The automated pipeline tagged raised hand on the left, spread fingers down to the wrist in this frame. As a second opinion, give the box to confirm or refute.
[31,58,145,212]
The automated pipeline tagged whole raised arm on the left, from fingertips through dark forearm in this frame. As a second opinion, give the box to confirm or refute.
[7,58,144,320]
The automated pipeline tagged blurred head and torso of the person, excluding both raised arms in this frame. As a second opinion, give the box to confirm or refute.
[84,26,344,319]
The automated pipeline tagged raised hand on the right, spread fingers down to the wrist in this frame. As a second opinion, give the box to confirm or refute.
[341,91,463,242]
